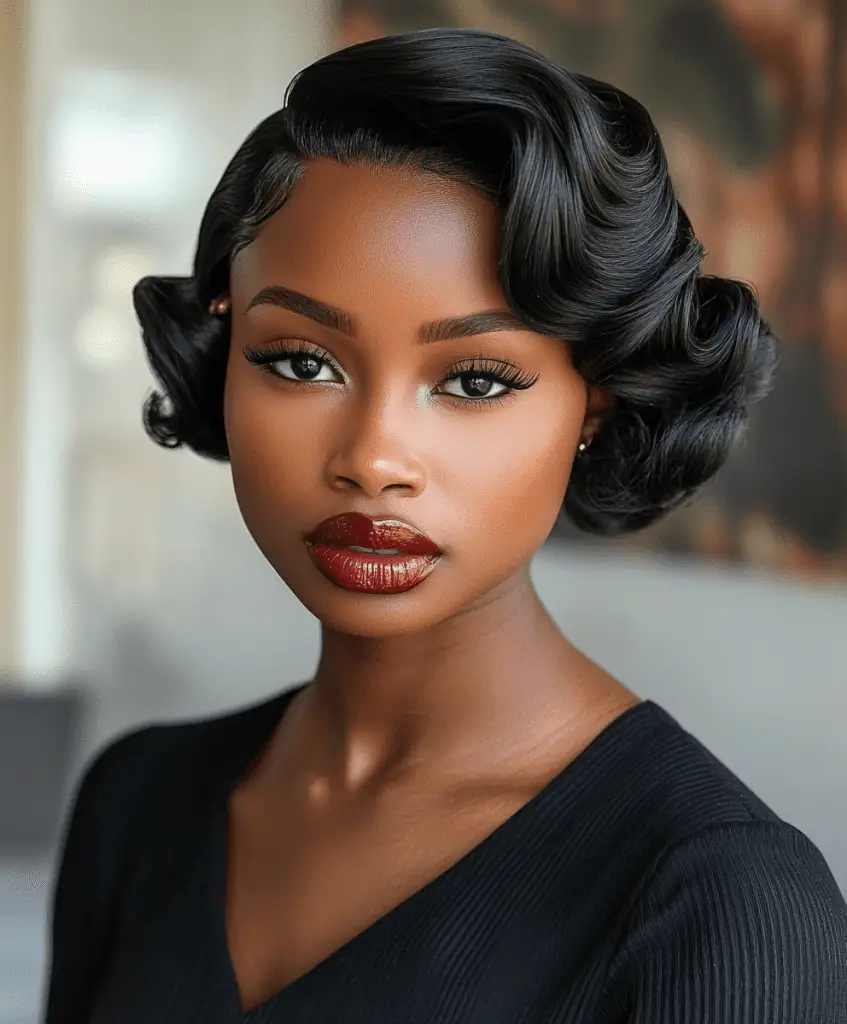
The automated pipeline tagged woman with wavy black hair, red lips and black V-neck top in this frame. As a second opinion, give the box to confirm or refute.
[47,29,847,1024]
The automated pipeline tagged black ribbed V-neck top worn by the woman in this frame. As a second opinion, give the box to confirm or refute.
[44,688,847,1024]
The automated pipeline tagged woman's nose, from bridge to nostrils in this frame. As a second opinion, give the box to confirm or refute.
[327,389,426,498]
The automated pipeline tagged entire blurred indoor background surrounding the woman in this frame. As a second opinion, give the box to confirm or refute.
[0,0,847,1024]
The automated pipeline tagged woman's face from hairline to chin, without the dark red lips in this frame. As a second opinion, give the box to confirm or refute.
[224,155,601,637]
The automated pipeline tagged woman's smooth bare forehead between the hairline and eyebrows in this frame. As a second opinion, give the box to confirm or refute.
[232,161,499,306]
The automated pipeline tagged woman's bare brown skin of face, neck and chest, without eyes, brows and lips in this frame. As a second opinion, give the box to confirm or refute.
[224,161,638,1007]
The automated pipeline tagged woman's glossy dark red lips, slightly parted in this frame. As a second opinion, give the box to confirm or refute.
[306,512,441,594]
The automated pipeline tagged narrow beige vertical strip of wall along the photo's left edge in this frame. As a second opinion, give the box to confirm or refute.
[0,0,25,674]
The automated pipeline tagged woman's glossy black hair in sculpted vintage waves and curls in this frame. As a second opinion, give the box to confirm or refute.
[133,29,775,535]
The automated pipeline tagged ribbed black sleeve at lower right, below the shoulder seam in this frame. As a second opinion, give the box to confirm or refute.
[607,821,847,1024]
